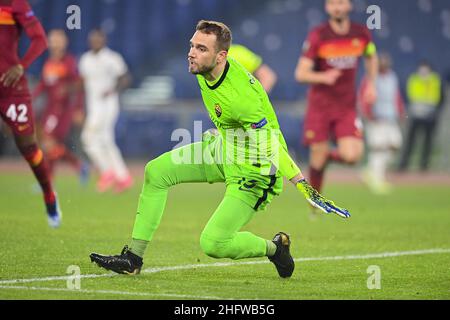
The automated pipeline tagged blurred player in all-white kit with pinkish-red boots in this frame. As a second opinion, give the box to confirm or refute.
[79,29,133,192]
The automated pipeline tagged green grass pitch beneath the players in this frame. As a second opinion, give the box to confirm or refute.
[0,172,450,300]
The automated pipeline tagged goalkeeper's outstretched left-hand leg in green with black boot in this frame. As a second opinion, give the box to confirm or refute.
[91,136,224,273]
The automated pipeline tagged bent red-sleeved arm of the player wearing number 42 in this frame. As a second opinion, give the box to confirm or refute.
[0,0,47,87]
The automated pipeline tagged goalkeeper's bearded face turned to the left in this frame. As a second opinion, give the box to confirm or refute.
[188,31,226,75]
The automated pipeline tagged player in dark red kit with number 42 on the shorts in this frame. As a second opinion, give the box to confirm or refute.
[0,0,61,227]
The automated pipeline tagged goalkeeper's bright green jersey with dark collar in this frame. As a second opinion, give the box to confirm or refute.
[197,57,287,176]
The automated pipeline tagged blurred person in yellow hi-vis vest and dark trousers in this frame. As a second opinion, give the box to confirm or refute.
[399,61,443,171]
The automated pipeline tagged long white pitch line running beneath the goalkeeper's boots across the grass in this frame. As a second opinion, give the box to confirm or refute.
[0,248,450,285]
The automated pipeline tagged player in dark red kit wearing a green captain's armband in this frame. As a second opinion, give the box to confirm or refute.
[295,0,378,215]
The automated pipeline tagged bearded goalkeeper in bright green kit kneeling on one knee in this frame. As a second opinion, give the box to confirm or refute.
[90,20,350,278]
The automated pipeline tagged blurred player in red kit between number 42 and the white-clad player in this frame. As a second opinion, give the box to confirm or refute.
[33,29,88,182]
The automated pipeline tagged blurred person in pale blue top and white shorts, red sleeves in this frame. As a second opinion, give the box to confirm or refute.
[358,53,405,194]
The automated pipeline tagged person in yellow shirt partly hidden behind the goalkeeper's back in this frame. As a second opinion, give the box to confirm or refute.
[228,44,277,93]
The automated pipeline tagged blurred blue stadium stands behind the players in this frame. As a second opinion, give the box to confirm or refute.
[3,0,450,169]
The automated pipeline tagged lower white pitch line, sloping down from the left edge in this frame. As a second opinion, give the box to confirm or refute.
[0,286,230,300]
